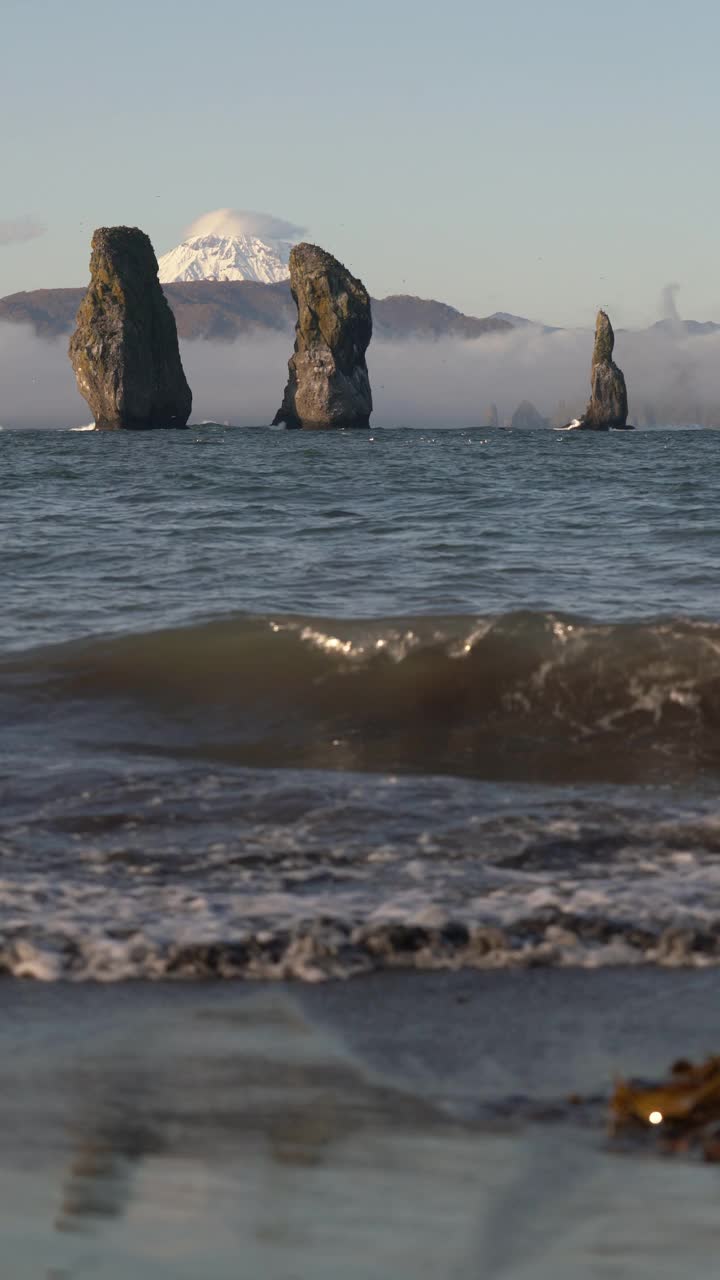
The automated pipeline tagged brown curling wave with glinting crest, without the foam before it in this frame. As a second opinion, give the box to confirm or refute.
[0,612,720,782]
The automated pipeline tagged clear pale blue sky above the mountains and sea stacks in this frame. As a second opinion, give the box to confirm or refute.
[0,0,720,324]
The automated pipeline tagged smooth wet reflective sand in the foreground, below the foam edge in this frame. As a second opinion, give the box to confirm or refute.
[0,969,720,1280]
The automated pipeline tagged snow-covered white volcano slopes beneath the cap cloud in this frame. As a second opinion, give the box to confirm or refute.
[158,234,292,284]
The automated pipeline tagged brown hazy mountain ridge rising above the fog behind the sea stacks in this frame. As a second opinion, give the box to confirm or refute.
[0,280,514,342]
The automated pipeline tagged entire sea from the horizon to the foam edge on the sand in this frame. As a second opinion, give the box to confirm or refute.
[0,424,720,980]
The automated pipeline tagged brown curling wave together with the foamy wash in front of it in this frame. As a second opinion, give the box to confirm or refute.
[7,612,720,982]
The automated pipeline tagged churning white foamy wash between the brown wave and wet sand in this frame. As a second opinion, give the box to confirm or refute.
[0,774,720,982]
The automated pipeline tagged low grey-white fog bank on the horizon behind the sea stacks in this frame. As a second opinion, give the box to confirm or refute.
[0,324,720,428]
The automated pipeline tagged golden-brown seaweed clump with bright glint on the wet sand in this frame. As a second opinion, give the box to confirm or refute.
[610,1056,720,1162]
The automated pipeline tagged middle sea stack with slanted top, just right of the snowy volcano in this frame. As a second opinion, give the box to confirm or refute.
[273,244,373,428]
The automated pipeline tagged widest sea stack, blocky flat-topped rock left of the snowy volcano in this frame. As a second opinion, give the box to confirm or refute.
[69,227,192,430]
